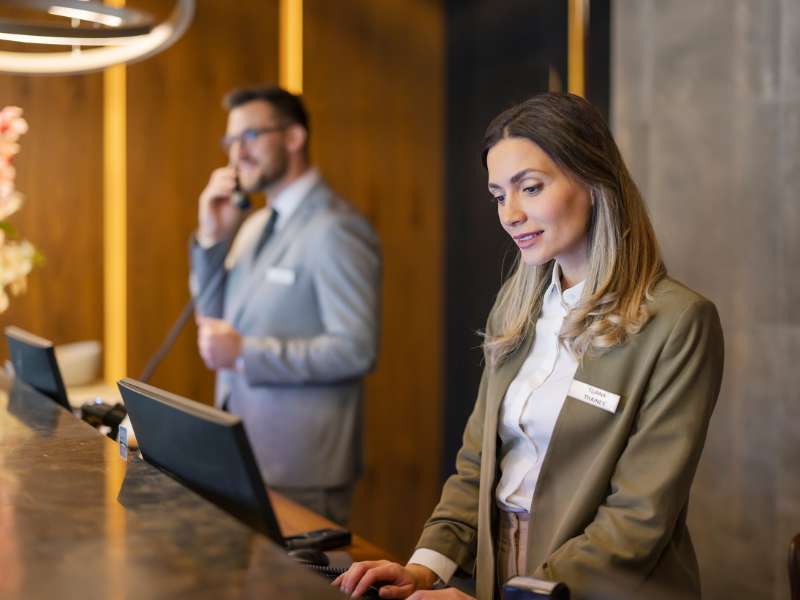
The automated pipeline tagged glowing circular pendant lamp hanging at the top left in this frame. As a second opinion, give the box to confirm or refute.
[0,0,195,75]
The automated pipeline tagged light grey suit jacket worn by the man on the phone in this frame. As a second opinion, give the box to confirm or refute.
[191,181,381,488]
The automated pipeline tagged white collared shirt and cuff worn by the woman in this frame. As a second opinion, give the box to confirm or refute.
[408,263,584,582]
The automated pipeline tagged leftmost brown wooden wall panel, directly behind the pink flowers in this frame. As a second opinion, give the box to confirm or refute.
[0,74,103,359]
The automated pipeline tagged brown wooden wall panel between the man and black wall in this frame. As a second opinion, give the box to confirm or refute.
[304,0,444,558]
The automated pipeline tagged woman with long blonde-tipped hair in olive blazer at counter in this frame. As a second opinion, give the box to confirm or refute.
[334,94,723,600]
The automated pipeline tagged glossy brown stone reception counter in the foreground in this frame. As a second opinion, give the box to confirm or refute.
[0,375,380,600]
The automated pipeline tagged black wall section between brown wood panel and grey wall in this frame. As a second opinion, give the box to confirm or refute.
[442,0,609,477]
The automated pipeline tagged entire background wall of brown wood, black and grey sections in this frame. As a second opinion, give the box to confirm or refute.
[0,0,800,599]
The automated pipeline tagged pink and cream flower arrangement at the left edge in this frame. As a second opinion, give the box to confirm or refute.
[0,106,41,313]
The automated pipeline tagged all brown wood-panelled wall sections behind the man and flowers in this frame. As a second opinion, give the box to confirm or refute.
[0,0,444,557]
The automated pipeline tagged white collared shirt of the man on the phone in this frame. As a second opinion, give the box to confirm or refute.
[225,168,320,269]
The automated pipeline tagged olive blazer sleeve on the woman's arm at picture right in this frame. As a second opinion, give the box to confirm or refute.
[534,299,724,591]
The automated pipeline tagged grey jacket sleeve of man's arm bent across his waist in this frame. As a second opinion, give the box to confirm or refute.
[242,213,381,385]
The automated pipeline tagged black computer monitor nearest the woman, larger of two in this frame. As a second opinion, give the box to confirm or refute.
[118,379,286,546]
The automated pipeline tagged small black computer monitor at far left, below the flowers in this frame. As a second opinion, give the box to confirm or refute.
[6,326,72,411]
